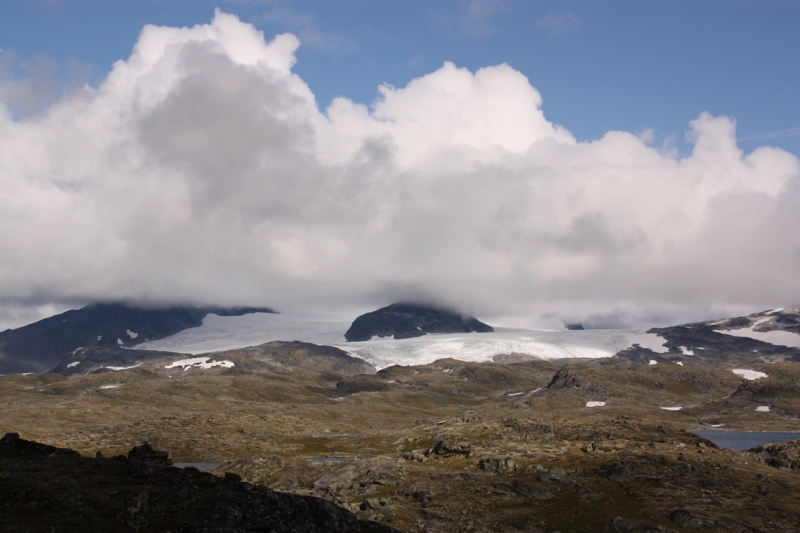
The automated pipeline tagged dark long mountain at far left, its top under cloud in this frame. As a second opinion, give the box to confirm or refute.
[0,303,273,373]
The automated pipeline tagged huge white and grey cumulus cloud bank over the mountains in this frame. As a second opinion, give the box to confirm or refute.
[0,12,800,323]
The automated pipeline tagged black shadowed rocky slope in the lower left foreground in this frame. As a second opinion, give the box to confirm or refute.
[0,433,396,533]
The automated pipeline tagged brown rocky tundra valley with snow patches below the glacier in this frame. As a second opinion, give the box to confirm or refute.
[0,306,800,533]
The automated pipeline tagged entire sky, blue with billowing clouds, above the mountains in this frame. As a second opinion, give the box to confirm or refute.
[0,0,800,329]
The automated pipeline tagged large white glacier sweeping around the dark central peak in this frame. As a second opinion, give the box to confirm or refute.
[135,313,800,370]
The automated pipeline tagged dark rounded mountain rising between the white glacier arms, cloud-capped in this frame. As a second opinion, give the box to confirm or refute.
[344,303,494,342]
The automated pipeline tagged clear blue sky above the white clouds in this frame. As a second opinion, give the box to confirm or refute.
[0,0,800,154]
